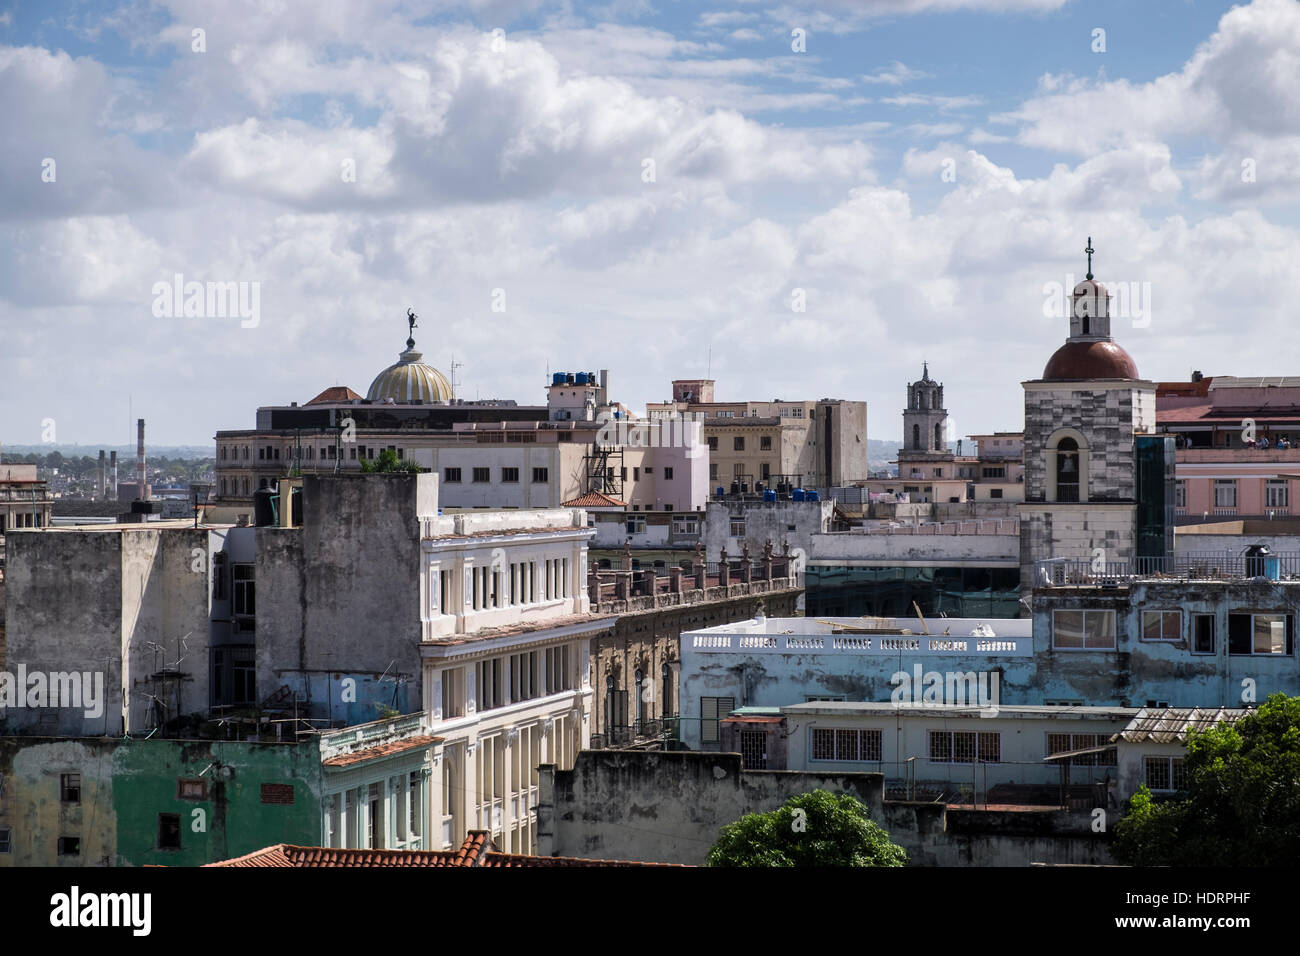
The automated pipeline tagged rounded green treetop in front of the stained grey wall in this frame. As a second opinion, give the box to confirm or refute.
[707,790,907,866]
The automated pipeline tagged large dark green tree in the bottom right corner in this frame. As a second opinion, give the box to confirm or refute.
[1112,693,1300,866]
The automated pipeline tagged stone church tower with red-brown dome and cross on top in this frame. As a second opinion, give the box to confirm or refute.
[1021,237,1173,594]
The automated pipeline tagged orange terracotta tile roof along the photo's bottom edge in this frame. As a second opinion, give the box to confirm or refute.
[207,830,683,868]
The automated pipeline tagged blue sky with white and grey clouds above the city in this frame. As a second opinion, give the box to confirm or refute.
[0,0,1300,445]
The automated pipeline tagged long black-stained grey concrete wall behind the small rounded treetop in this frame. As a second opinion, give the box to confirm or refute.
[537,750,1112,866]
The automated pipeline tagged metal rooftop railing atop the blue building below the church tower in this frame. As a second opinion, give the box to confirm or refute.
[1034,551,1300,588]
